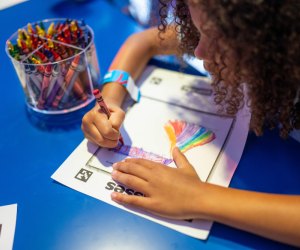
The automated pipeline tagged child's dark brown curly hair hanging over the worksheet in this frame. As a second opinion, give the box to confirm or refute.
[159,0,300,137]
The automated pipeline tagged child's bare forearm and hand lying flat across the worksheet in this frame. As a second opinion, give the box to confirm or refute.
[112,148,300,246]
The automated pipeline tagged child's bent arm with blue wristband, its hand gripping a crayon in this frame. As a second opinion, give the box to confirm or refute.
[81,28,178,148]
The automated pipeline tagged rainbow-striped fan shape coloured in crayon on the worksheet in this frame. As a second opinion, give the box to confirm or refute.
[164,120,216,153]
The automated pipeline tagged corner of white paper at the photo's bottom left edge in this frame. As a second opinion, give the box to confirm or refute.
[0,204,17,250]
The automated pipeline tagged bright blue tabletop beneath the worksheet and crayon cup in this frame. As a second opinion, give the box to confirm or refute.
[0,0,300,250]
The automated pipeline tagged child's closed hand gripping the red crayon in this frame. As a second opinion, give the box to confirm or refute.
[81,105,125,148]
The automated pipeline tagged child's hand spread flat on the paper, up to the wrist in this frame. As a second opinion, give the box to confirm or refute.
[111,148,205,219]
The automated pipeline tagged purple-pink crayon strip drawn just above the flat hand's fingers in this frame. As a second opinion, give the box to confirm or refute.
[111,145,173,165]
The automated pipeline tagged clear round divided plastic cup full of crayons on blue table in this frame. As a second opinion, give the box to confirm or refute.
[5,18,100,116]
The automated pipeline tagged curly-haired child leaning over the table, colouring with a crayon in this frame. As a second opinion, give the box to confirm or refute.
[82,0,300,246]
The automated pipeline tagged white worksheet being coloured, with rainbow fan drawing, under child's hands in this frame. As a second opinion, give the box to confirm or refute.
[52,67,250,239]
